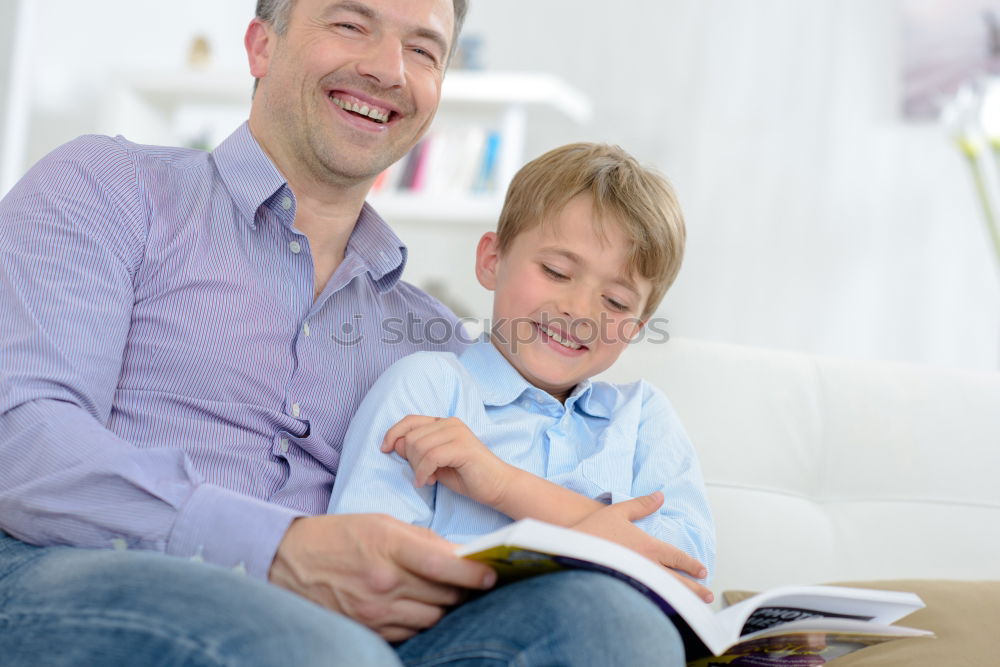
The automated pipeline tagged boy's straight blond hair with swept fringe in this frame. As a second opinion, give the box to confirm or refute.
[497,143,685,320]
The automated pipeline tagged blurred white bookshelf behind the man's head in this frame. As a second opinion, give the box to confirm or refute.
[100,70,592,223]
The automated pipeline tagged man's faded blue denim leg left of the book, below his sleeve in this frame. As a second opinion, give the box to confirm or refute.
[0,532,399,667]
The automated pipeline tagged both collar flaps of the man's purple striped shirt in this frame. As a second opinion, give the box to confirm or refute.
[212,122,407,293]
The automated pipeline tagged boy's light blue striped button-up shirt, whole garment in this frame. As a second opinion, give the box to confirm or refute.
[330,341,715,572]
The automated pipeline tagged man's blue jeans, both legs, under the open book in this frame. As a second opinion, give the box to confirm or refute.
[0,532,684,667]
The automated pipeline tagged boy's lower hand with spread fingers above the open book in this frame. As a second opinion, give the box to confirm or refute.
[571,491,715,602]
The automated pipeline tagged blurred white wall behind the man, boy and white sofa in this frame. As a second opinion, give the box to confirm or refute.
[7,0,1000,369]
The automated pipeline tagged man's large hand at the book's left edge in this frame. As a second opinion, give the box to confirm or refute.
[268,514,496,642]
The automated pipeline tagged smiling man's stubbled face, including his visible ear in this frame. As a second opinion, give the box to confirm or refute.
[247,0,454,183]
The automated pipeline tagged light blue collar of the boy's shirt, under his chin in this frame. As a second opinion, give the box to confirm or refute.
[460,336,617,419]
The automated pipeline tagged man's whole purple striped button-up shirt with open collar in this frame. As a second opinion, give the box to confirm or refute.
[0,124,461,577]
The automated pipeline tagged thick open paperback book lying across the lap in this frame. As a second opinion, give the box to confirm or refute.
[457,519,932,667]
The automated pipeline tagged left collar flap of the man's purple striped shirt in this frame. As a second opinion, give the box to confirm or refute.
[212,122,287,227]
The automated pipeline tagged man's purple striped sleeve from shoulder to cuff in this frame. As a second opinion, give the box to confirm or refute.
[0,137,299,577]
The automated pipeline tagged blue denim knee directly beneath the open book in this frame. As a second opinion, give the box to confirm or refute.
[397,571,685,667]
